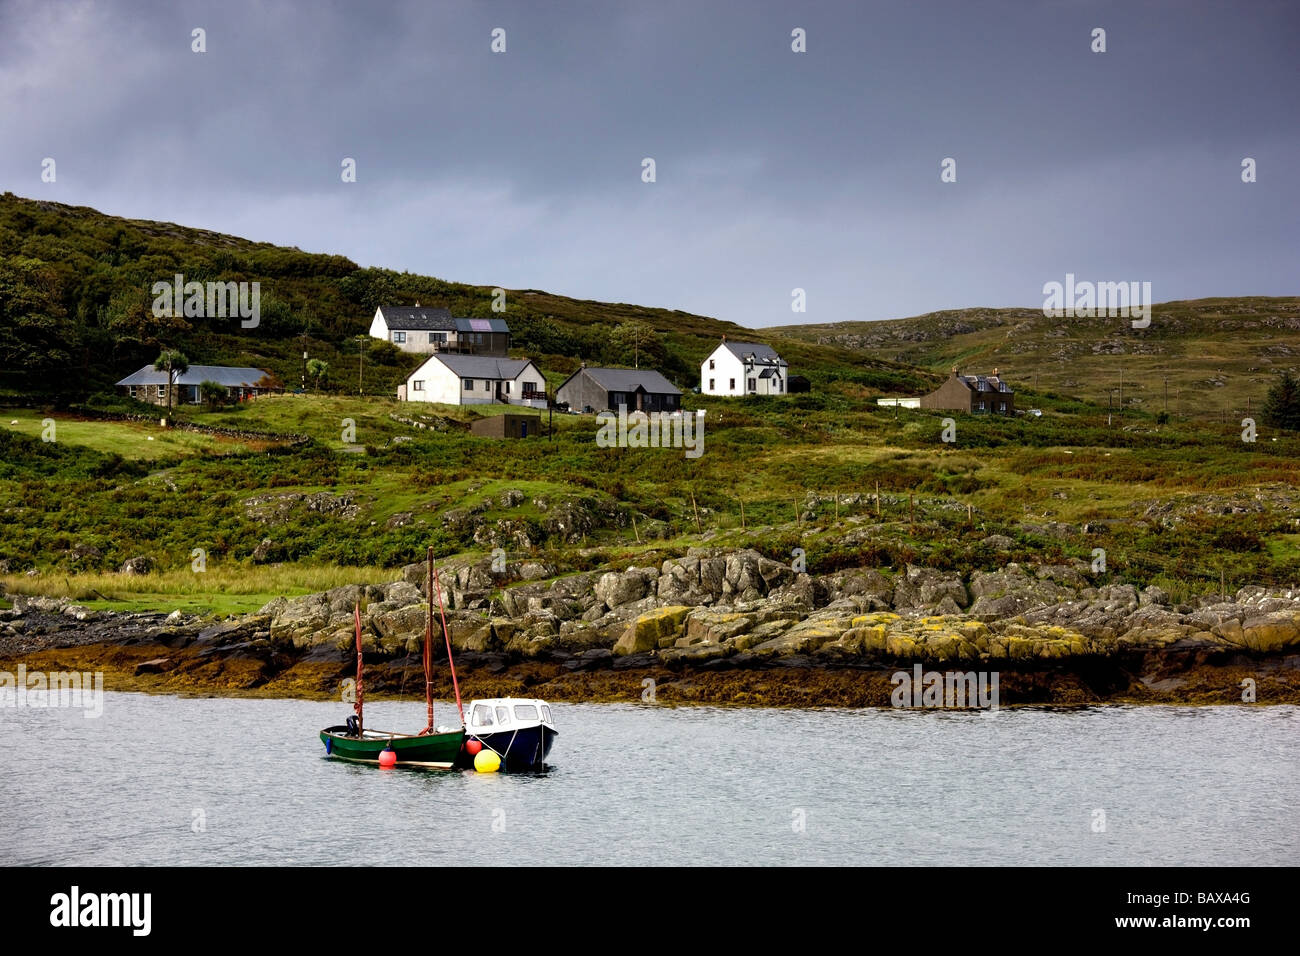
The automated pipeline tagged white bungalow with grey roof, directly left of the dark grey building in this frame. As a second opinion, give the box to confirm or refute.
[398,352,546,408]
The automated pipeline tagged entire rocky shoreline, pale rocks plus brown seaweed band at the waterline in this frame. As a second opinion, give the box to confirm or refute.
[0,549,1300,706]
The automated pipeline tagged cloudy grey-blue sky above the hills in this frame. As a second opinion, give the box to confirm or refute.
[0,0,1300,328]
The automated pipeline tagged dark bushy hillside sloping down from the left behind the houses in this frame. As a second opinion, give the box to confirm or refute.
[0,193,928,402]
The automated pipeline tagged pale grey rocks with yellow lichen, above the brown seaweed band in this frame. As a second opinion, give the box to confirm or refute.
[134,549,1300,667]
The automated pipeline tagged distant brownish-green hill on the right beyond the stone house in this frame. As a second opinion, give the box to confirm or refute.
[768,297,1300,420]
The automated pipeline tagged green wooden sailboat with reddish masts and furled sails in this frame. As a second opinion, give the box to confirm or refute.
[321,548,465,770]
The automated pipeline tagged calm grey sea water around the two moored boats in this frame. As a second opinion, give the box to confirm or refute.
[0,693,1300,865]
